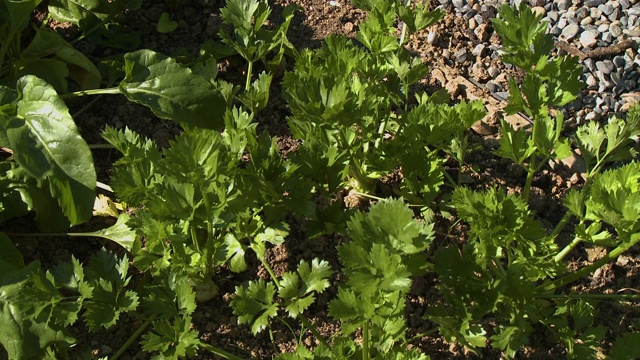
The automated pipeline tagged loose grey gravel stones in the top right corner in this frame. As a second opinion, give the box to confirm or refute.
[439,0,640,125]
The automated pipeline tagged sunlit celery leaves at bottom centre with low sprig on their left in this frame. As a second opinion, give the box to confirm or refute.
[231,199,435,360]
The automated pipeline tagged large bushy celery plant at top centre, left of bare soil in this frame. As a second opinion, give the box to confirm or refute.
[283,1,484,204]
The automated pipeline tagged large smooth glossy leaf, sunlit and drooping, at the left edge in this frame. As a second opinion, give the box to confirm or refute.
[7,76,96,228]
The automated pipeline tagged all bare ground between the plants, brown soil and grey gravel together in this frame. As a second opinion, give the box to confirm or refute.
[5,0,640,359]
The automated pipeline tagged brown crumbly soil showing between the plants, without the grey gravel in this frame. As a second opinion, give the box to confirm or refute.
[5,0,640,359]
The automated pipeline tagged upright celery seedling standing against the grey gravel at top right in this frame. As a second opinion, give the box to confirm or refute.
[493,4,582,199]
